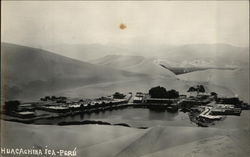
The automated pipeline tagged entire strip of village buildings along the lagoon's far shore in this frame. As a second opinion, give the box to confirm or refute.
[1,88,250,126]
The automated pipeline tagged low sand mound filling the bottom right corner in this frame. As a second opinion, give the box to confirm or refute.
[143,136,248,157]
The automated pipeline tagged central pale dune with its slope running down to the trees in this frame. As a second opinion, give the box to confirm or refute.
[58,55,237,97]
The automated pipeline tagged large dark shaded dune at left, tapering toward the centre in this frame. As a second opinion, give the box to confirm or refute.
[1,43,146,99]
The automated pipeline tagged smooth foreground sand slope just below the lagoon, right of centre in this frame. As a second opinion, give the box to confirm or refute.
[114,126,227,157]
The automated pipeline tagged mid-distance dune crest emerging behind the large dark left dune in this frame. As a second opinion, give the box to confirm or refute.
[92,55,175,77]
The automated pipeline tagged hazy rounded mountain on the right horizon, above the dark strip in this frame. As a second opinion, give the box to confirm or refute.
[160,44,249,68]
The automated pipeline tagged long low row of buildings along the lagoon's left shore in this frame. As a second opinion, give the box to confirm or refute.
[2,93,132,119]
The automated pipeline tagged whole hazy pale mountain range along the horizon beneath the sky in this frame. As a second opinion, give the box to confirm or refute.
[44,44,249,67]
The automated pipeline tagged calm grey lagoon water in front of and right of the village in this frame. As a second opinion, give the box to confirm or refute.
[35,108,250,128]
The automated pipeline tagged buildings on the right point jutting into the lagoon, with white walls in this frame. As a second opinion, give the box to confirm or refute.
[185,96,247,127]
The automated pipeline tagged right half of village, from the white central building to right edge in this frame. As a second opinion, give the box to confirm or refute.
[129,88,250,126]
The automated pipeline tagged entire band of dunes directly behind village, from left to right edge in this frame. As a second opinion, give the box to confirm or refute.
[1,43,245,102]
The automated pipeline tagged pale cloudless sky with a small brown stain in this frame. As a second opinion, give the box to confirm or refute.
[1,1,249,47]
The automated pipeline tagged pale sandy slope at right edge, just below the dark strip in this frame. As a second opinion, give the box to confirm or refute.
[178,68,249,103]
